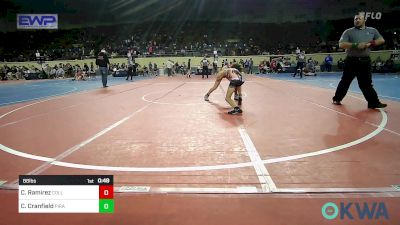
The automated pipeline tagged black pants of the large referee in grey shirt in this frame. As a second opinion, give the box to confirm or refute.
[333,57,379,105]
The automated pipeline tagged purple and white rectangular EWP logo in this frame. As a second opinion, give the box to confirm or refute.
[17,14,58,29]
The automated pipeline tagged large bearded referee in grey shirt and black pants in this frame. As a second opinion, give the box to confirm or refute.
[332,12,387,109]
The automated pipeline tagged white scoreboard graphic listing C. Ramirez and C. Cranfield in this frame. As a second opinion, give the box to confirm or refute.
[18,175,114,213]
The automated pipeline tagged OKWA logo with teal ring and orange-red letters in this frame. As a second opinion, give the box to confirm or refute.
[321,202,389,220]
